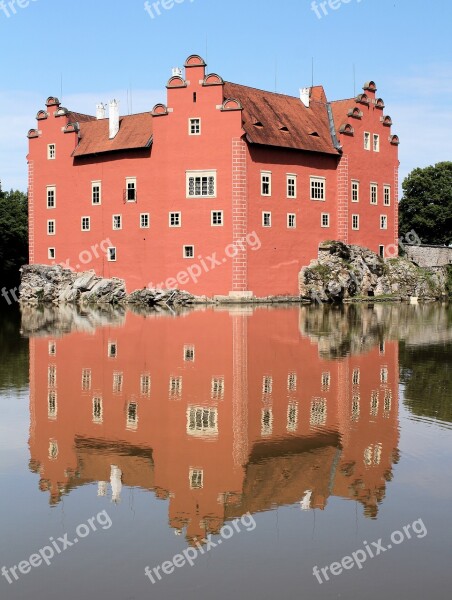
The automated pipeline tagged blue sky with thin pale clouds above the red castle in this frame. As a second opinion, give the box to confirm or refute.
[0,0,452,191]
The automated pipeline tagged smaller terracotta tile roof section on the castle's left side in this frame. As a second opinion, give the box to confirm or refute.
[72,113,152,156]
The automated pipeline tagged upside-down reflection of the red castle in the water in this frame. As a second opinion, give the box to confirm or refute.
[26,307,398,539]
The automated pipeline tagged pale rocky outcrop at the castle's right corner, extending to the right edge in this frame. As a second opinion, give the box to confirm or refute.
[299,242,447,302]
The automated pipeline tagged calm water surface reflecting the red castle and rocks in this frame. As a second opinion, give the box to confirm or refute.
[0,305,452,600]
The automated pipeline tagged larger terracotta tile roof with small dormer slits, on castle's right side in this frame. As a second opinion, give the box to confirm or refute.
[224,82,338,155]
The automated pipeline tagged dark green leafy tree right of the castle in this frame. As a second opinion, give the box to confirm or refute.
[399,162,452,246]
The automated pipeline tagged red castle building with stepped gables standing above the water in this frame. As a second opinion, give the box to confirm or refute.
[27,55,399,297]
